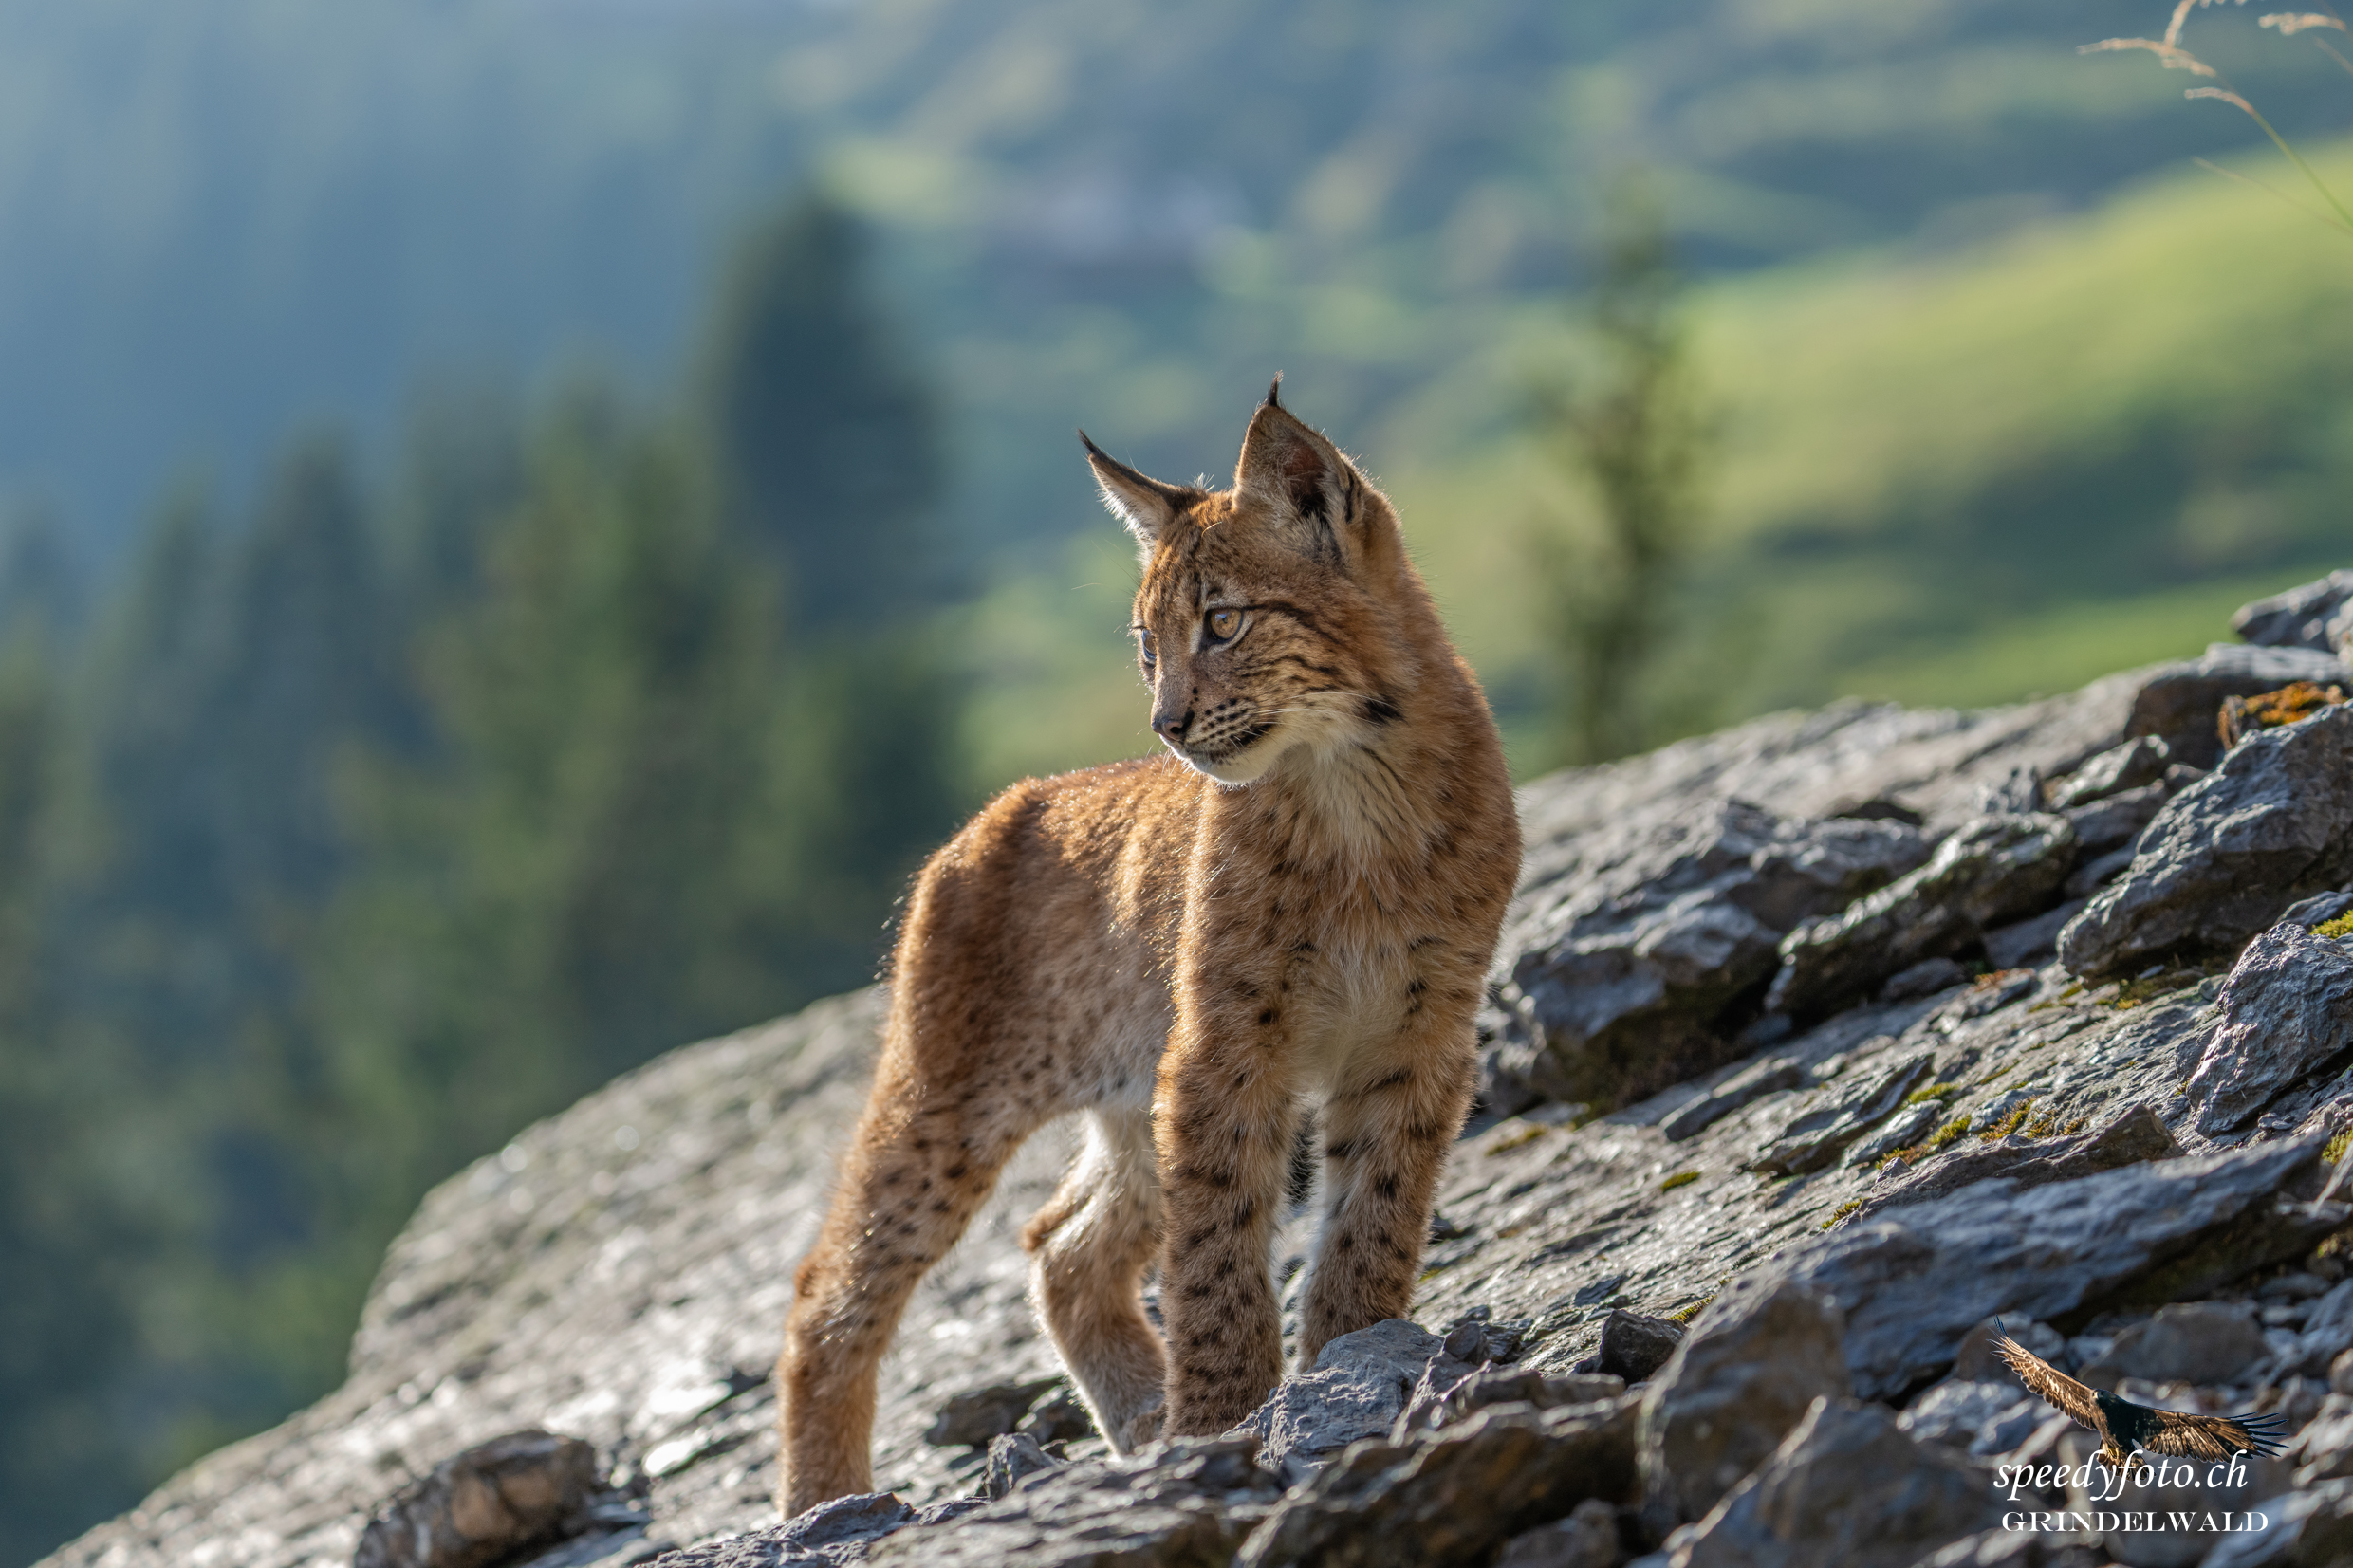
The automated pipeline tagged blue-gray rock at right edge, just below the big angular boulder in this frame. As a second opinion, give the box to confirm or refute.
[2183,921,2353,1137]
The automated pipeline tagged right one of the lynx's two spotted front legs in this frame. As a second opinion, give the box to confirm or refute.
[1299,1025,1475,1368]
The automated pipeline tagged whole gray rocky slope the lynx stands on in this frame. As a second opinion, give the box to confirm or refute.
[49,574,2353,1568]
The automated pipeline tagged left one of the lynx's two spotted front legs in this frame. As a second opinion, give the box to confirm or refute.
[1156,1013,1299,1436]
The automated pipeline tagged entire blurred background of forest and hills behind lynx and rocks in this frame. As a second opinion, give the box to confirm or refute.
[0,0,2353,1568]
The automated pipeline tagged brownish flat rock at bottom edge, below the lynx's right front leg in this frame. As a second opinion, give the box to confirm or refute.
[1235,1399,1636,1568]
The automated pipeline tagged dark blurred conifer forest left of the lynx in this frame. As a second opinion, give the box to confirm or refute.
[0,193,962,1563]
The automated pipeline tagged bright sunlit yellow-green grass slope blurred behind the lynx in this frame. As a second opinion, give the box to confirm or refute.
[970,146,2353,781]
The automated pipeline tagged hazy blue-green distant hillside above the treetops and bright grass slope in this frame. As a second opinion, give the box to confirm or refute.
[0,0,2344,554]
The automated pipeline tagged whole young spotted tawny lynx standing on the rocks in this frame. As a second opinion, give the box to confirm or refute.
[776,393,1520,1514]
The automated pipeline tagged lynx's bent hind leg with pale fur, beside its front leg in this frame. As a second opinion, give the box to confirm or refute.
[1021,1110,1167,1453]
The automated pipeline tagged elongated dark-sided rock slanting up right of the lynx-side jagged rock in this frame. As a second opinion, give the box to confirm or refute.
[1765,813,2075,1018]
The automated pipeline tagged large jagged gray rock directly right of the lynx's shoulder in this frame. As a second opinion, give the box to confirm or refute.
[1499,800,1927,1105]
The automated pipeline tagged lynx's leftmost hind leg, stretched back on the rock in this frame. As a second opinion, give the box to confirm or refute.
[776,1085,1030,1519]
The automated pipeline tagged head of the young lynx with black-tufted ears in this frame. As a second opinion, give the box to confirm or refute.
[1080,378,1436,785]
